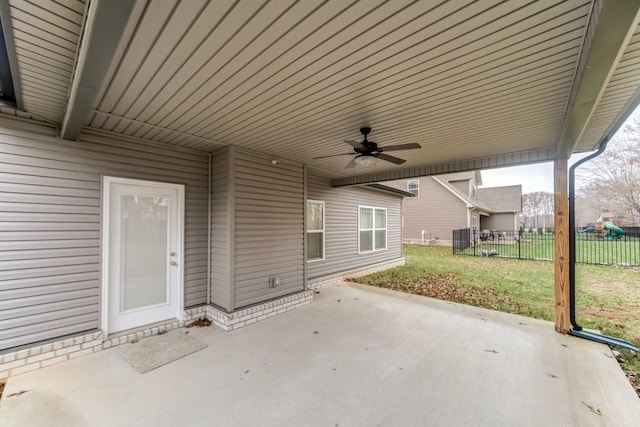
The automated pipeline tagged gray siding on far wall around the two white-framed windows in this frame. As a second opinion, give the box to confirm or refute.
[307,174,406,279]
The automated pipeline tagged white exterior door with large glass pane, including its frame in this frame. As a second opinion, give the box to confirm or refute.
[102,177,184,333]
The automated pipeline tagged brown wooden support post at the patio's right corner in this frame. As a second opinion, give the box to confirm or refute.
[553,158,571,333]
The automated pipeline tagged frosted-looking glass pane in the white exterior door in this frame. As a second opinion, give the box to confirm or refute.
[120,195,169,311]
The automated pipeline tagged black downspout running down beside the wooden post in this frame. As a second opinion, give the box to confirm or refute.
[569,138,638,351]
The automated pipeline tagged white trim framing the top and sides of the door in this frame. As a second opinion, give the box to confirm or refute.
[100,176,185,335]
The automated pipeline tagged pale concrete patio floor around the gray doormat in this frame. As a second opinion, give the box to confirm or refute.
[0,283,640,427]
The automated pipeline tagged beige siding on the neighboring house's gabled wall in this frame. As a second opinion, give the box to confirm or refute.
[393,176,469,242]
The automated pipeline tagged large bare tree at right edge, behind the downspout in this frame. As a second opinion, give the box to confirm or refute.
[577,113,640,225]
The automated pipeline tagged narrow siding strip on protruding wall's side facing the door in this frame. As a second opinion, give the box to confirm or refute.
[211,148,233,310]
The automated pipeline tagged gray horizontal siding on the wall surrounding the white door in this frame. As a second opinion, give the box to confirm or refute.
[0,125,208,349]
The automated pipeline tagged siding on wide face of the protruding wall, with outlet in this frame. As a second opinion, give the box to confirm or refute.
[233,150,304,308]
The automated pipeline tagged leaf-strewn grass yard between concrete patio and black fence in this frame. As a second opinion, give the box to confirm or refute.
[357,245,640,395]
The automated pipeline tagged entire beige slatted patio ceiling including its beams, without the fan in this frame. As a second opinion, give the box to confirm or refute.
[3,0,640,184]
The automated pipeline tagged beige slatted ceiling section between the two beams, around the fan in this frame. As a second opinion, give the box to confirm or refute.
[87,1,591,176]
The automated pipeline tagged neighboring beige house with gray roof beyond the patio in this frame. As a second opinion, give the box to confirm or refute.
[387,171,522,244]
